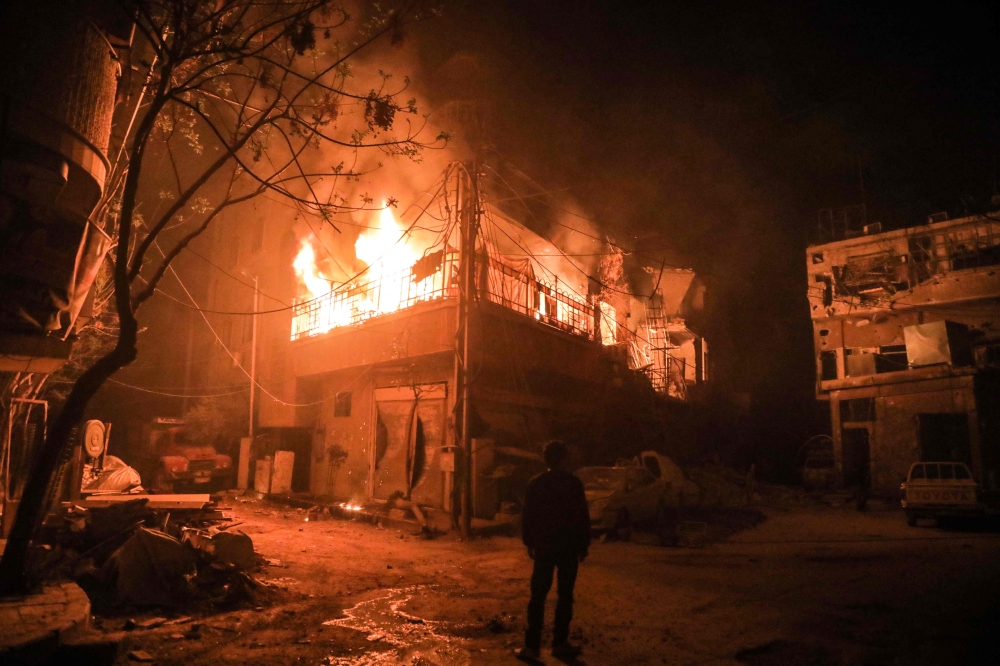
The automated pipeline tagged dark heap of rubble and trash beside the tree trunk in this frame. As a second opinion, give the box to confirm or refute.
[33,495,273,613]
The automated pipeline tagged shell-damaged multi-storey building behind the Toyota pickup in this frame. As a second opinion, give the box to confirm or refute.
[806,214,1000,493]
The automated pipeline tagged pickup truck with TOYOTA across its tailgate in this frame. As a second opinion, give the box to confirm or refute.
[899,462,985,527]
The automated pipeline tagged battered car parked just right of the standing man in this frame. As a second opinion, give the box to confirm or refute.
[576,465,670,541]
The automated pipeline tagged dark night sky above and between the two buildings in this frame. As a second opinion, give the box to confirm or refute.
[415,0,1000,464]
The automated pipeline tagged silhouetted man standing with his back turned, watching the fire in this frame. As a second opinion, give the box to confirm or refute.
[517,440,590,661]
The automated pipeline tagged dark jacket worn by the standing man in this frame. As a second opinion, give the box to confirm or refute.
[521,470,590,556]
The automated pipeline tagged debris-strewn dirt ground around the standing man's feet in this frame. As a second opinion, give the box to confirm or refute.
[98,501,1000,666]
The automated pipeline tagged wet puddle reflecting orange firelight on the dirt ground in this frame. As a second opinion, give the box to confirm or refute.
[323,585,472,666]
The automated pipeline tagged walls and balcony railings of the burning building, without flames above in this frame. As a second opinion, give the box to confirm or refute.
[195,183,704,518]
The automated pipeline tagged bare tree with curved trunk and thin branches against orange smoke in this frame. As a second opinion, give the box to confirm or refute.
[0,0,447,594]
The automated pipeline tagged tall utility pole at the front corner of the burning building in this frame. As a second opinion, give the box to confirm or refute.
[458,161,479,539]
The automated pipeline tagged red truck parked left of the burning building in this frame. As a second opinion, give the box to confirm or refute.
[146,417,233,493]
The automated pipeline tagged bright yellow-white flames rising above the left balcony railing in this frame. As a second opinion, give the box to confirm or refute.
[292,207,441,340]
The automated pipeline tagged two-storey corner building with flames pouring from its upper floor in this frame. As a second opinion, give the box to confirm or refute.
[195,163,707,518]
